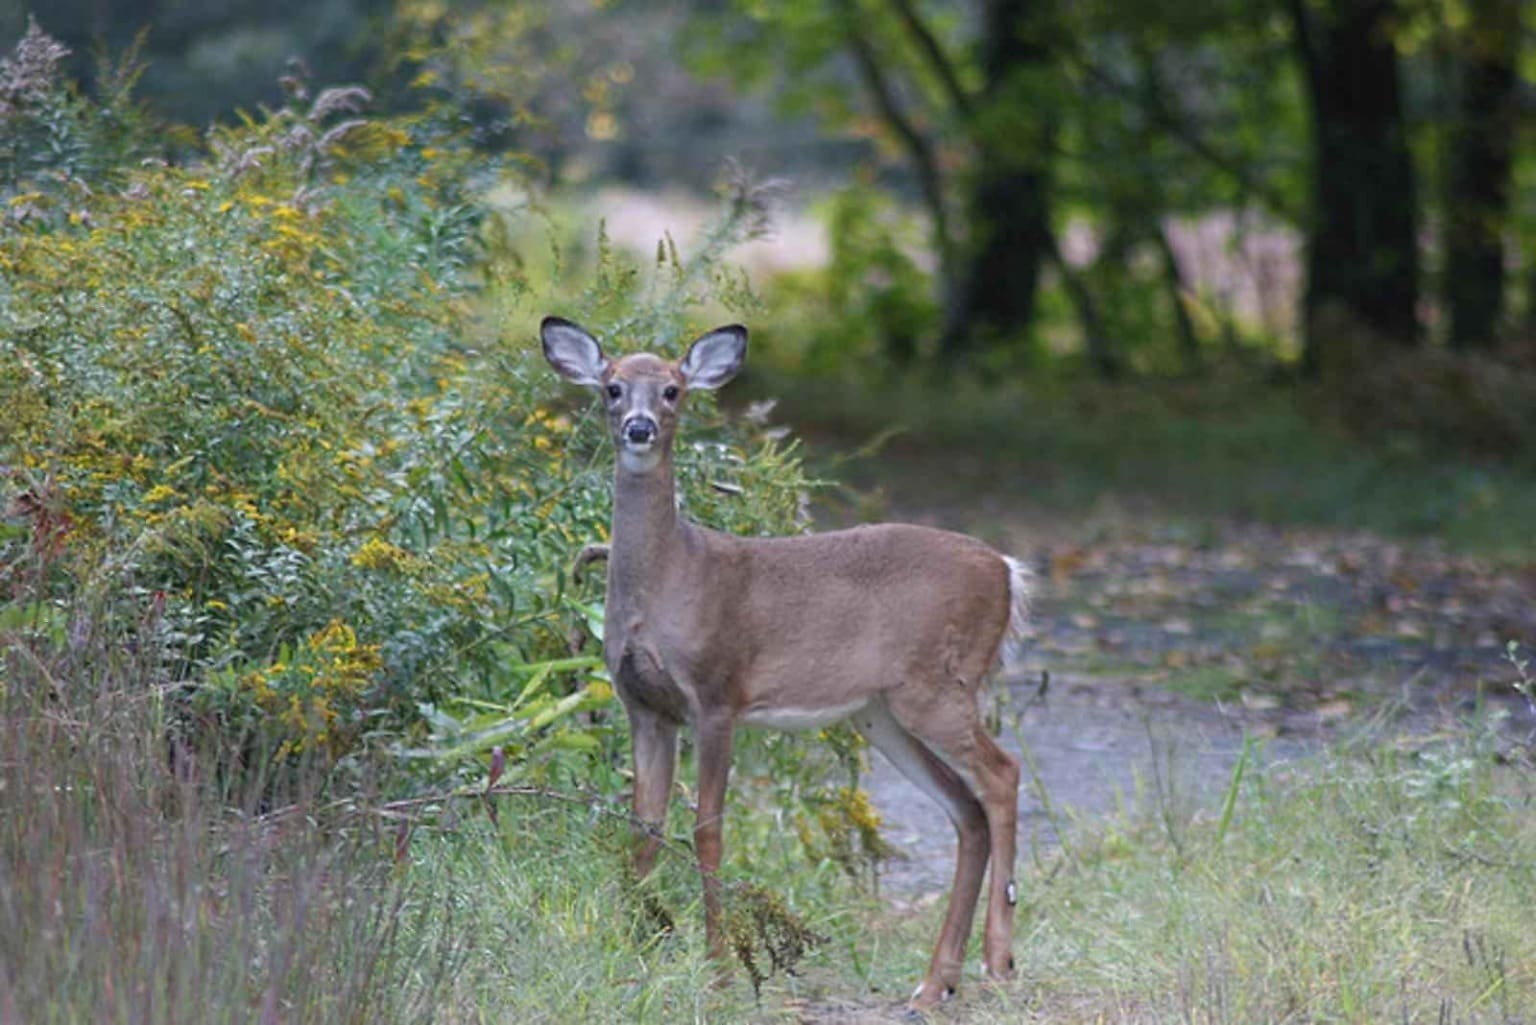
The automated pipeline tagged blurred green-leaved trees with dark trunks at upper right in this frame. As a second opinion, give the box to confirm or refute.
[691,0,1536,375]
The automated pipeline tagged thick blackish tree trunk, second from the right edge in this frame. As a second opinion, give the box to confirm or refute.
[1290,0,1419,372]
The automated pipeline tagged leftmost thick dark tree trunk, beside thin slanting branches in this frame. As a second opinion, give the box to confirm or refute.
[942,0,1052,363]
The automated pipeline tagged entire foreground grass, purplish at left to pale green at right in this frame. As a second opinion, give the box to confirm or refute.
[9,654,1536,1023]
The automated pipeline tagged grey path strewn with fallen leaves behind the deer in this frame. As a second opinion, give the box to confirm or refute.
[866,510,1536,905]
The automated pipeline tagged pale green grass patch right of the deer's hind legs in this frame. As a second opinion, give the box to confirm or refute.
[1029,735,1536,1022]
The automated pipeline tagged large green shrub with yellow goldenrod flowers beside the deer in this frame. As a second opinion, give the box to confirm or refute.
[0,28,805,782]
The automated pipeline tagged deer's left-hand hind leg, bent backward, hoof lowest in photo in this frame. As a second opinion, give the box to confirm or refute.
[852,699,988,1008]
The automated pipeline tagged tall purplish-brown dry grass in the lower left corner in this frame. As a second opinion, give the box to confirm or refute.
[0,622,455,1023]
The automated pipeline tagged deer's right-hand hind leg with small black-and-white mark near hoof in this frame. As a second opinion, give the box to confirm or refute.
[891,692,1018,979]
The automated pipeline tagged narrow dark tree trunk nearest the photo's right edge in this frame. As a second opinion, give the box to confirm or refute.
[1445,0,1521,349]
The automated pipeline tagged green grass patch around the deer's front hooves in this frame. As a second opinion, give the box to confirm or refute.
[390,798,857,1022]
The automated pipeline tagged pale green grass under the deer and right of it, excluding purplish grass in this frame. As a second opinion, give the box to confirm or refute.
[416,706,1536,1022]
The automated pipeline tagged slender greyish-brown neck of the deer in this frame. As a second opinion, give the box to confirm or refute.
[608,452,682,601]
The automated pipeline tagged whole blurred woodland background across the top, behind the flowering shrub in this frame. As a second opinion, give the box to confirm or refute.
[0,0,1536,384]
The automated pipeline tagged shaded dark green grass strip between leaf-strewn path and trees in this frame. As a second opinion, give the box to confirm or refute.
[753,370,1536,559]
